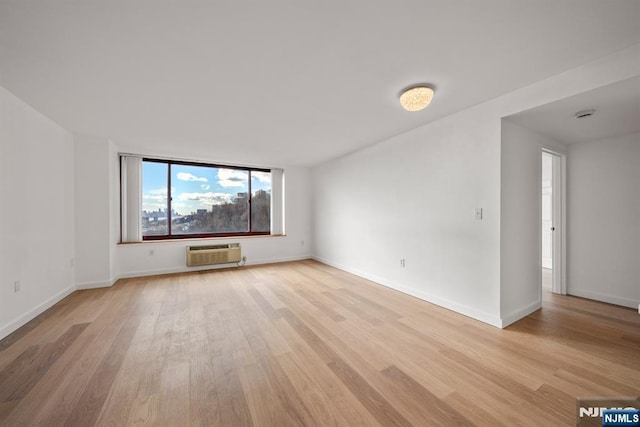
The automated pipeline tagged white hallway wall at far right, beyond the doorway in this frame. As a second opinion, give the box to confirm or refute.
[567,133,640,307]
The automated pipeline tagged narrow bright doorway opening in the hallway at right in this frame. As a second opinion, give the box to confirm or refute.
[540,149,567,294]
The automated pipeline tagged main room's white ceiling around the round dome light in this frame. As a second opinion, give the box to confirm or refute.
[0,0,640,166]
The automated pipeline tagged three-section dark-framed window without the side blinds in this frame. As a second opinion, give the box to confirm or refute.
[142,159,271,240]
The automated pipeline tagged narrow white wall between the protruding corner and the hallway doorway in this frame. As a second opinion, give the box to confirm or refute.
[500,120,566,325]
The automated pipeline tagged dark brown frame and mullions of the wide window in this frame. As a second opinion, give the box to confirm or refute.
[142,157,272,242]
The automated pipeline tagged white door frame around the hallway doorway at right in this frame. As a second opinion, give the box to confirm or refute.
[538,146,567,295]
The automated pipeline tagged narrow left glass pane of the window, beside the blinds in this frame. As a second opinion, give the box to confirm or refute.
[142,162,169,236]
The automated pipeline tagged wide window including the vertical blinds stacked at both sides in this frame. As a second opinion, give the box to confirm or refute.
[121,155,283,242]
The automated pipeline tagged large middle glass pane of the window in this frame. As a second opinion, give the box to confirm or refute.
[171,164,249,234]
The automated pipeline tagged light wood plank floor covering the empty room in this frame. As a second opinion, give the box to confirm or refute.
[0,261,640,426]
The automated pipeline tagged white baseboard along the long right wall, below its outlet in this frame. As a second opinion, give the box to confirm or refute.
[312,256,503,328]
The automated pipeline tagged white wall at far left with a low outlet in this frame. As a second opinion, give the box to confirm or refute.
[0,88,75,338]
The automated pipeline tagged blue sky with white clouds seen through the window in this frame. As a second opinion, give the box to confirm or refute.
[142,162,271,215]
